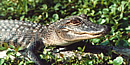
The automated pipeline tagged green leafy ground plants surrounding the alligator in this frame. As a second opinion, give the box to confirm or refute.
[0,0,130,65]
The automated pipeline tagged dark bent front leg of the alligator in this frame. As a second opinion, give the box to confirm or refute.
[27,41,48,65]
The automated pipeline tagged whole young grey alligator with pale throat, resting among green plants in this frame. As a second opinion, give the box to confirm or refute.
[0,14,109,65]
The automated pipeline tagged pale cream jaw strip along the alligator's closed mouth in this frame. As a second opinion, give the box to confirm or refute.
[59,31,104,41]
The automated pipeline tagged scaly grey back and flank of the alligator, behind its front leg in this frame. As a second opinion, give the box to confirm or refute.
[0,20,44,48]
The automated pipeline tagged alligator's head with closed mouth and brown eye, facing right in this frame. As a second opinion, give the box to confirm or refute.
[43,14,110,46]
